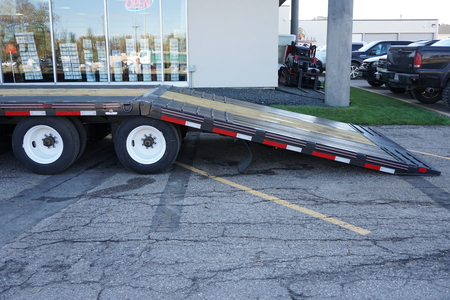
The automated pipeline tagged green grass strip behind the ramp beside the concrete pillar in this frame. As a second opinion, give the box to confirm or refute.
[273,87,450,125]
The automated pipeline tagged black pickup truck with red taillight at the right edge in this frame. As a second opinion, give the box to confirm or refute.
[378,39,450,108]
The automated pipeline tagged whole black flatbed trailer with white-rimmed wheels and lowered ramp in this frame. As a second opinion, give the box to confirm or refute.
[0,86,440,175]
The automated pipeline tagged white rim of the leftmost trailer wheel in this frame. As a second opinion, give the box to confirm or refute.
[22,125,64,164]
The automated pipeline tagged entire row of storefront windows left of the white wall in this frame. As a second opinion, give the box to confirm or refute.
[0,0,187,83]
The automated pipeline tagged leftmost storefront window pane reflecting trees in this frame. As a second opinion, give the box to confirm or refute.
[0,0,53,83]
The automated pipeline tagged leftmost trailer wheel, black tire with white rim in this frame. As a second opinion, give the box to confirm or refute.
[12,117,80,175]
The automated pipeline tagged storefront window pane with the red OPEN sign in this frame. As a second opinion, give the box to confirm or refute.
[108,0,162,82]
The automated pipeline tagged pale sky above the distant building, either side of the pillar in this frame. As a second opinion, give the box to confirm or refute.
[285,0,450,24]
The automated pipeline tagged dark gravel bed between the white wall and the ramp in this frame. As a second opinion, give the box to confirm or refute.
[194,86,328,106]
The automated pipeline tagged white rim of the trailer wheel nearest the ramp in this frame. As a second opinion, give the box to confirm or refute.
[126,125,167,165]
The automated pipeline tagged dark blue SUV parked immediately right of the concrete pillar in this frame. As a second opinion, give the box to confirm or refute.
[350,41,412,79]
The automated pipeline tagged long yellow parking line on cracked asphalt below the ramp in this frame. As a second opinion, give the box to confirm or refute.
[175,162,371,235]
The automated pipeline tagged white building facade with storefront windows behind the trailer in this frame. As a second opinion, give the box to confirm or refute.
[0,0,278,87]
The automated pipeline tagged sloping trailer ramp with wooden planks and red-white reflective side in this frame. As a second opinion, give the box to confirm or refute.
[139,86,440,175]
